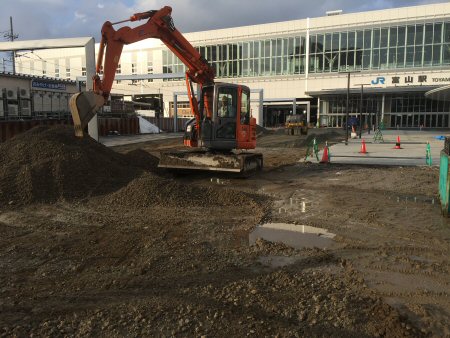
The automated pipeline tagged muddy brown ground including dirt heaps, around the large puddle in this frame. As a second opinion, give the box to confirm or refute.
[0,125,450,337]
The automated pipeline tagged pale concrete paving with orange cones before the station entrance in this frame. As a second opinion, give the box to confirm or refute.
[313,130,446,166]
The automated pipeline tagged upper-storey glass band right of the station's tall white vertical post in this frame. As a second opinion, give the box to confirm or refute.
[309,22,450,73]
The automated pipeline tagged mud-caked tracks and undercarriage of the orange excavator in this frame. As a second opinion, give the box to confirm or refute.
[158,150,263,174]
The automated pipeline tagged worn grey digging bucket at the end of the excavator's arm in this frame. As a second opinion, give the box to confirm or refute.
[69,92,105,137]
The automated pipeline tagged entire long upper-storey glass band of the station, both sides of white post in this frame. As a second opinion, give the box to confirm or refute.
[163,22,450,78]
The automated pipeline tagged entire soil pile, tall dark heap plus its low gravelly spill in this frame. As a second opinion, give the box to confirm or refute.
[0,126,264,207]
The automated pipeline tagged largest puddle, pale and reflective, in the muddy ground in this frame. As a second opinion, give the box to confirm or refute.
[249,223,336,249]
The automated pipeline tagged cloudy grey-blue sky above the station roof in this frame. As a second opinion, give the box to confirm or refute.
[0,0,446,41]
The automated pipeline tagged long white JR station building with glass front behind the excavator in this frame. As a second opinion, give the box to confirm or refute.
[12,2,450,128]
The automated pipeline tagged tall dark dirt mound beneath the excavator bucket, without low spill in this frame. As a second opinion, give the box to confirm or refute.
[0,126,138,205]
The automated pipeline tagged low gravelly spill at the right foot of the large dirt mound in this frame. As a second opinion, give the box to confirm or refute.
[104,172,260,208]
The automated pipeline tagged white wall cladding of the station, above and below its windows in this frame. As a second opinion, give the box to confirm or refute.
[11,2,450,125]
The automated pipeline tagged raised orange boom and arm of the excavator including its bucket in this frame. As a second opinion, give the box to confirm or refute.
[70,6,215,137]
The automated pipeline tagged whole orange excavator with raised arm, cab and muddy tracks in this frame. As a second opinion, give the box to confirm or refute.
[70,6,263,173]
